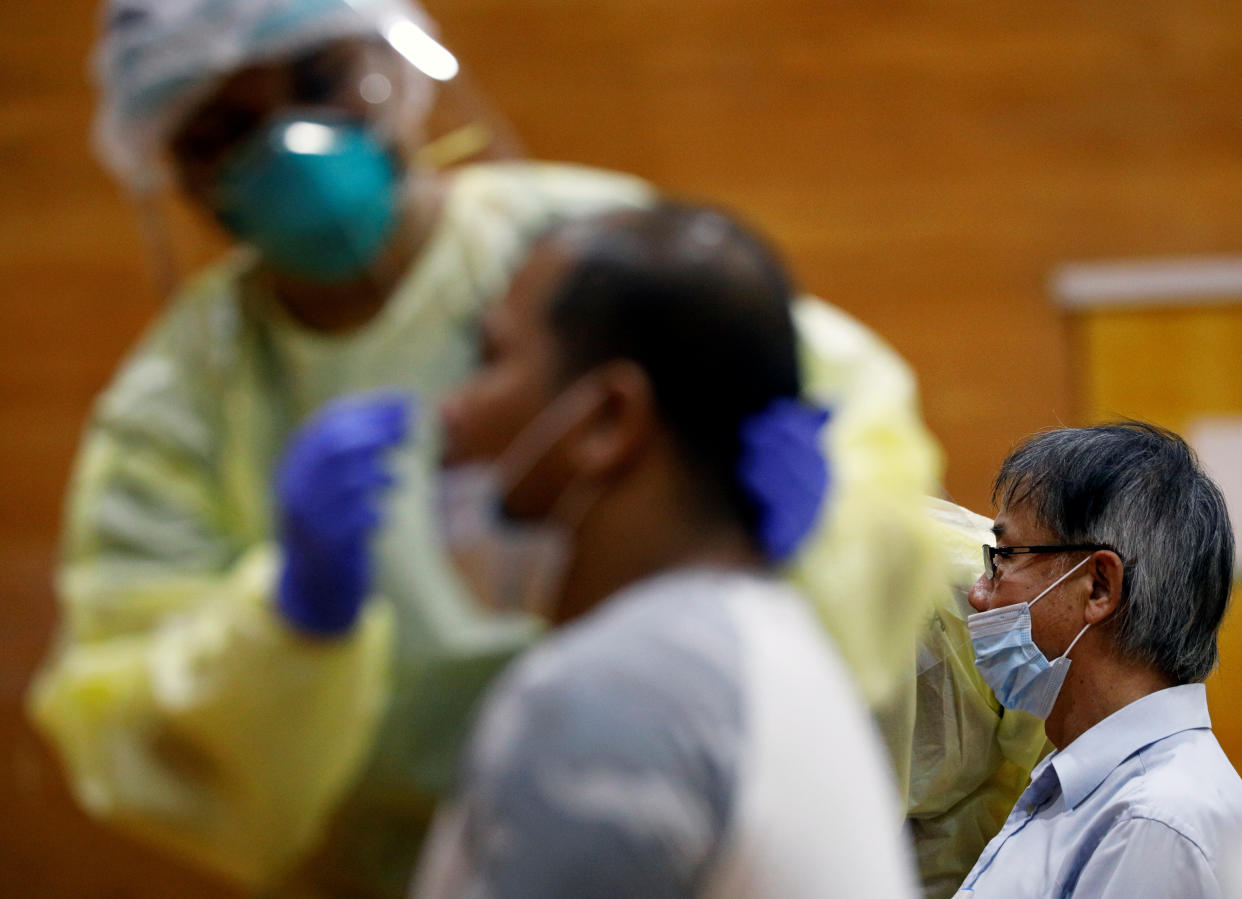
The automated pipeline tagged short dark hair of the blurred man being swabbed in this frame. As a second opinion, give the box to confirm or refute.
[548,201,801,533]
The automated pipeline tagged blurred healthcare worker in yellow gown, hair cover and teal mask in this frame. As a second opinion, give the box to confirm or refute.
[30,0,1042,895]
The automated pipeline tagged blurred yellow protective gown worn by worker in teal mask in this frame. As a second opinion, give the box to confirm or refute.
[30,164,1042,895]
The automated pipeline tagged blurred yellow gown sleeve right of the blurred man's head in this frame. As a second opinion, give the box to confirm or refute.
[791,298,945,707]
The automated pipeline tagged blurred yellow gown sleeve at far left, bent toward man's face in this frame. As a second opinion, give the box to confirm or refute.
[27,279,392,887]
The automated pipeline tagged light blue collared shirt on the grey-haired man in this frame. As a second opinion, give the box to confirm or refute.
[958,684,1242,899]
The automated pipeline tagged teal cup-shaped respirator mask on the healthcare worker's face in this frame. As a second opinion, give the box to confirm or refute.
[212,117,399,283]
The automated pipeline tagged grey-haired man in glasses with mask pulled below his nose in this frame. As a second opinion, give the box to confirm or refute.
[958,422,1242,899]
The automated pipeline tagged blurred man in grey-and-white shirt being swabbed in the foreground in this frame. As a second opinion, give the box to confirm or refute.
[415,205,914,899]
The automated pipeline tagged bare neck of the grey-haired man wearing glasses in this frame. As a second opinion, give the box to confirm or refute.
[1045,641,1174,750]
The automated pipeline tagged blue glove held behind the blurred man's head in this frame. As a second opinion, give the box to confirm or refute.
[738,397,828,562]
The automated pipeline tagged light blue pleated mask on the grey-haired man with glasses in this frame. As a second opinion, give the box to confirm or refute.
[966,556,1090,718]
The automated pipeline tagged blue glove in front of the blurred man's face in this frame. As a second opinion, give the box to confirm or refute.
[276,392,411,636]
